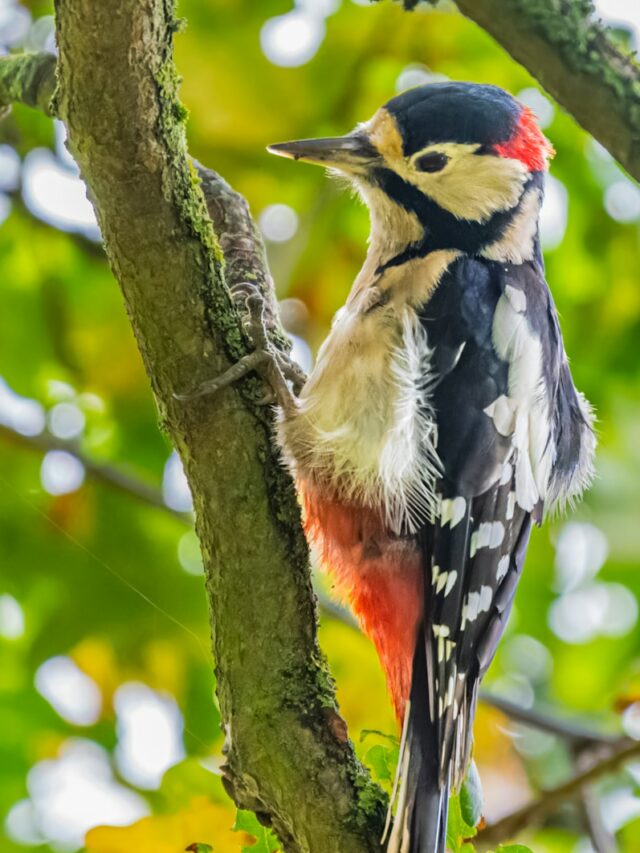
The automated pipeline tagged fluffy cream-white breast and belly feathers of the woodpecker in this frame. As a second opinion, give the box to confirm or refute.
[280,253,451,534]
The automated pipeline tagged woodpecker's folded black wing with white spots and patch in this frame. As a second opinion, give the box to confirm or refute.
[420,258,559,787]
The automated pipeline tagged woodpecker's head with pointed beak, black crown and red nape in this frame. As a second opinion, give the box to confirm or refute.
[269,83,553,262]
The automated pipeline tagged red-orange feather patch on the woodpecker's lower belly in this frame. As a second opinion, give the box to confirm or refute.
[299,483,423,724]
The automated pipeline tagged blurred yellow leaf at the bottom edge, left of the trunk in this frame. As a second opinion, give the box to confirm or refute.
[85,797,253,853]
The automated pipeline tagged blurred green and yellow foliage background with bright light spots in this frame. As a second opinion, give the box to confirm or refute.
[0,0,640,853]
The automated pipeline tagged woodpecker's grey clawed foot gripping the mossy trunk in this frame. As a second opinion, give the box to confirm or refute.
[175,282,306,412]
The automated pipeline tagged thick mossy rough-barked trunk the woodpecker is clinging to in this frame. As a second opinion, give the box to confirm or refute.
[54,0,384,853]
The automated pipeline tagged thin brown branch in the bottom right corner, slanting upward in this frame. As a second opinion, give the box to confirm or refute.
[474,738,640,849]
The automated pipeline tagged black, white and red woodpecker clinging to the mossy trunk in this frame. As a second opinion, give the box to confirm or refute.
[269,82,595,853]
